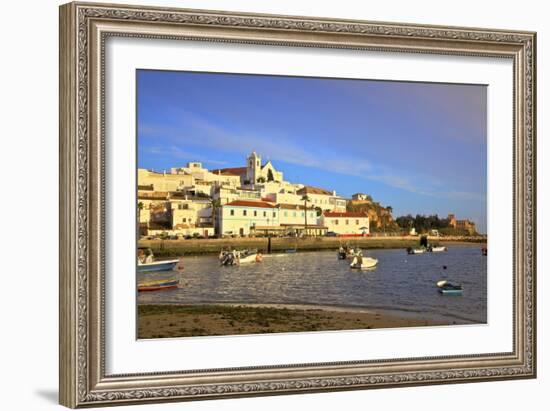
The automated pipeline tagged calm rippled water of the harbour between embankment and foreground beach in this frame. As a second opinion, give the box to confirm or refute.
[138,245,487,323]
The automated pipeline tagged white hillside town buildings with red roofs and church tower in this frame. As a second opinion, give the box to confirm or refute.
[137,151,475,238]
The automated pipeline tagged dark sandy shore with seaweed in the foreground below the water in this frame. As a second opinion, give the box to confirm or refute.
[138,303,474,339]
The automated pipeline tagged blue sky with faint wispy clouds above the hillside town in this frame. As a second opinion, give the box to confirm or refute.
[137,70,487,232]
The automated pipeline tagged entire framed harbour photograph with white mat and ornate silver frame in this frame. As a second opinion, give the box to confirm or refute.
[60,3,536,408]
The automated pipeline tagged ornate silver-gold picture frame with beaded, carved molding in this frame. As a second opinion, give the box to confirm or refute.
[59,3,536,408]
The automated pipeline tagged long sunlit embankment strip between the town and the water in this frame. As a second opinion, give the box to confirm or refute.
[138,236,487,257]
